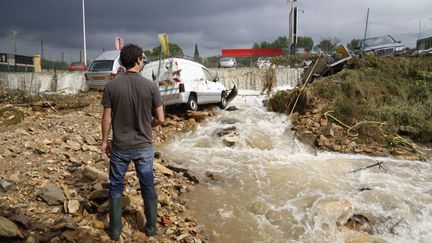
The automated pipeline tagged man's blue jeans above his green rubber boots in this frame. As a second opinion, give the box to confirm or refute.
[109,146,157,200]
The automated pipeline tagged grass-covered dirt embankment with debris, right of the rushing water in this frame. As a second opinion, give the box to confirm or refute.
[267,56,432,160]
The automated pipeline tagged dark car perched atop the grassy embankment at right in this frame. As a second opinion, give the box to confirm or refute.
[357,35,407,56]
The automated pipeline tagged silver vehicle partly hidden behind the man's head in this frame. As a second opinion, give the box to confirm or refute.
[85,50,126,89]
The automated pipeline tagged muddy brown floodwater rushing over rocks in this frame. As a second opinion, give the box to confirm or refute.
[162,91,432,242]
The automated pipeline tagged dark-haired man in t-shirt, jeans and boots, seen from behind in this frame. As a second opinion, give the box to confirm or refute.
[101,44,165,240]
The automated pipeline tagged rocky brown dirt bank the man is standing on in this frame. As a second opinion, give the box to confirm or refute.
[0,93,211,242]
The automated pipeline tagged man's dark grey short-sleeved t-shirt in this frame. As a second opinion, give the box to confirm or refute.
[101,72,162,149]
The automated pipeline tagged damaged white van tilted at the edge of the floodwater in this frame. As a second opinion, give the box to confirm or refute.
[141,58,237,111]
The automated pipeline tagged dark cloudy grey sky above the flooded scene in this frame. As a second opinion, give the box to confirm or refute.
[0,0,432,62]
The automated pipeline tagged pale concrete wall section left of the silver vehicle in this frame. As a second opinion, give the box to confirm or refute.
[0,72,88,95]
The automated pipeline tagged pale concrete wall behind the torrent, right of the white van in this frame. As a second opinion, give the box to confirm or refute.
[210,68,303,91]
